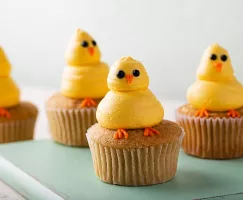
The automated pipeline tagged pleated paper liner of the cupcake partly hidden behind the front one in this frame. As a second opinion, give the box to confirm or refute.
[46,108,97,146]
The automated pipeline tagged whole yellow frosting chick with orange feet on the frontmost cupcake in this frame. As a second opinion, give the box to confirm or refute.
[96,57,164,139]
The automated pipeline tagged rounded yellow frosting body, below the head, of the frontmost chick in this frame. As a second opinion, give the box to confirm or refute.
[97,89,164,129]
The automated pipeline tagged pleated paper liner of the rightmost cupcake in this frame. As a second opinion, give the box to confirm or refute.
[176,111,243,159]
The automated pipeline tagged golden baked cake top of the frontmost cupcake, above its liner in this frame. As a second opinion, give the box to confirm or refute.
[87,120,184,149]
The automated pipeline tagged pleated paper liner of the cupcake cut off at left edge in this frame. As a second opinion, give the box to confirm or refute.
[0,118,36,143]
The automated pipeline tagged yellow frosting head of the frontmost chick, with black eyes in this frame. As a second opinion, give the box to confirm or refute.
[107,57,149,92]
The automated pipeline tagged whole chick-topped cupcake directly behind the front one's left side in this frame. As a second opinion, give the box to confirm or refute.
[46,29,109,146]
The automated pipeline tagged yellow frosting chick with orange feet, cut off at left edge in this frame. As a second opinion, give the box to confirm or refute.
[0,47,20,118]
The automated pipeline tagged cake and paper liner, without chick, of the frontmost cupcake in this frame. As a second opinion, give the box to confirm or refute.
[87,120,184,186]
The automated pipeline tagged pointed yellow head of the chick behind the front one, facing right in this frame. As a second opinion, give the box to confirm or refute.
[65,29,101,66]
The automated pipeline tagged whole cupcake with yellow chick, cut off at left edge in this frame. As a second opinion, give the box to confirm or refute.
[0,47,38,143]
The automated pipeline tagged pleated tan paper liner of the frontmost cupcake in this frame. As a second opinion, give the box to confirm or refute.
[87,123,184,186]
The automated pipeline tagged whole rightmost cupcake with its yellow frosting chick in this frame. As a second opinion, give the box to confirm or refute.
[176,44,243,159]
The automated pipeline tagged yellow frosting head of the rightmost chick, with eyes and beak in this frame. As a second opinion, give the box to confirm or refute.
[197,44,234,81]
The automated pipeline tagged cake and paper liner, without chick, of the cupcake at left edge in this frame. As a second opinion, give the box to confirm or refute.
[0,102,38,143]
